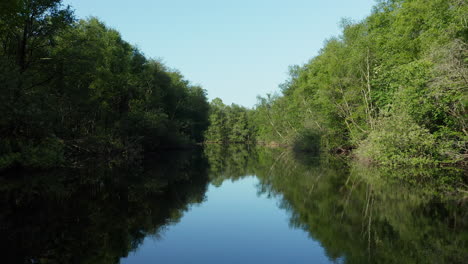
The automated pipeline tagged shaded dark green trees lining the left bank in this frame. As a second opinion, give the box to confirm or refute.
[0,0,209,169]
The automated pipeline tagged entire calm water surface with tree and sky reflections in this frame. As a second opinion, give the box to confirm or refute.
[0,145,468,264]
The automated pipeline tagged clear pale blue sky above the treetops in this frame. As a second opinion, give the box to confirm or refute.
[64,0,374,107]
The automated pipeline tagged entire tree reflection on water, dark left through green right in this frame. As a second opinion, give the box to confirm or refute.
[0,145,468,263]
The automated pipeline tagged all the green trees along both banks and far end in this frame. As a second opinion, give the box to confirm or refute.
[0,0,468,186]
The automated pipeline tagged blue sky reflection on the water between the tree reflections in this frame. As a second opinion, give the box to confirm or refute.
[121,177,332,264]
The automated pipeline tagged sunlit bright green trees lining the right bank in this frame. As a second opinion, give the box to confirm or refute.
[253,0,468,166]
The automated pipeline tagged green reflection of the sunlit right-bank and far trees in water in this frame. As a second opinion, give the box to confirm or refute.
[205,145,468,263]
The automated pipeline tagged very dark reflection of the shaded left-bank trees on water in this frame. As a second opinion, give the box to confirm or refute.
[0,152,208,263]
